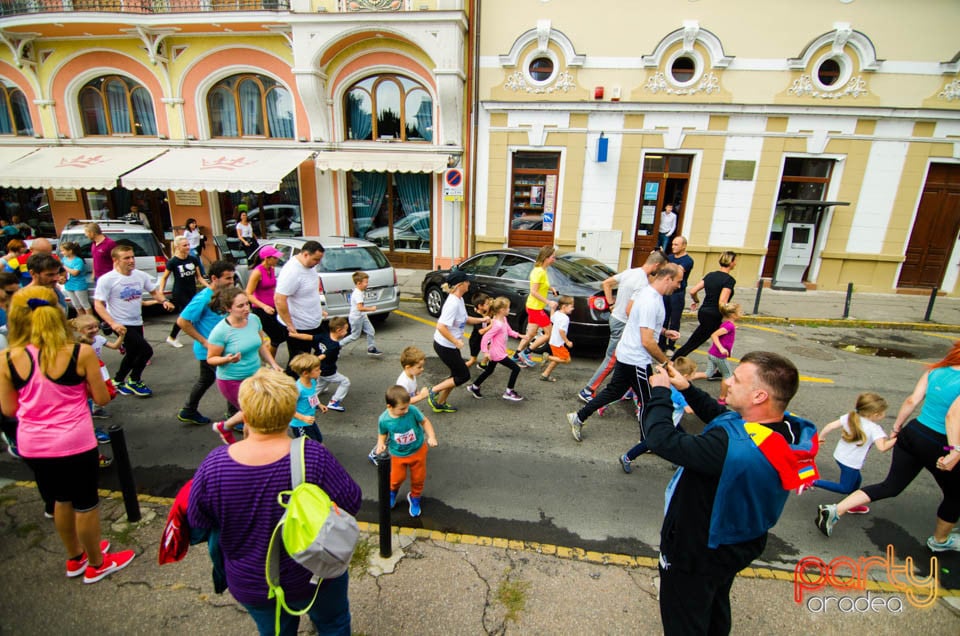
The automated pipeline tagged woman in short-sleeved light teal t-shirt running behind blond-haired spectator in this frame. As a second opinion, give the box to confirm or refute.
[207,287,283,436]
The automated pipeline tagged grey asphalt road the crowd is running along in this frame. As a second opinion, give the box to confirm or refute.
[0,303,960,589]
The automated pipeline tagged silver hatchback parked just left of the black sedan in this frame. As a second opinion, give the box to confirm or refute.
[236,236,400,322]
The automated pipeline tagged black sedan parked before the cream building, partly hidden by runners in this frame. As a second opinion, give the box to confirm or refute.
[420,248,616,352]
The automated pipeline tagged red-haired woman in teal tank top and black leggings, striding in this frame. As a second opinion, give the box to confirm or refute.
[817,340,960,552]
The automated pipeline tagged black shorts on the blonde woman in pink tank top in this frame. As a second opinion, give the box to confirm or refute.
[23,448,100,512]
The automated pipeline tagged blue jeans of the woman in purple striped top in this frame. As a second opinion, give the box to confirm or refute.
[243,572,350,636]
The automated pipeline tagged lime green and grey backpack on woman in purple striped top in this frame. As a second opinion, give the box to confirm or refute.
[266,437,360,634]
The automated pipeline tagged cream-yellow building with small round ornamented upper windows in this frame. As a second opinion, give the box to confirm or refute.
[474,0,960,295]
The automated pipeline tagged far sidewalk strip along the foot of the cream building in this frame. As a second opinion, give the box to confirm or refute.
[397,269,960,332]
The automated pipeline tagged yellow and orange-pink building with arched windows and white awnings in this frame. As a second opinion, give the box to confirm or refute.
[0,0,471,267]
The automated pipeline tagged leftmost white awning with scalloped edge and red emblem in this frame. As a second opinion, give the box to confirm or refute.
[0,146,164,190]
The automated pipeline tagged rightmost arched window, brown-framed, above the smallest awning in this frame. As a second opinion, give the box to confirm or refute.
[343,75,433,142]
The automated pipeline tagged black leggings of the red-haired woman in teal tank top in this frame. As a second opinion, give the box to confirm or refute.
[863,419,960,523]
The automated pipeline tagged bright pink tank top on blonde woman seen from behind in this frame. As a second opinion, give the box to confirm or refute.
[7,345,97,457]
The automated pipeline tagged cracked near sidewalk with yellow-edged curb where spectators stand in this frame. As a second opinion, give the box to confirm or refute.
[0,481,960,635]
